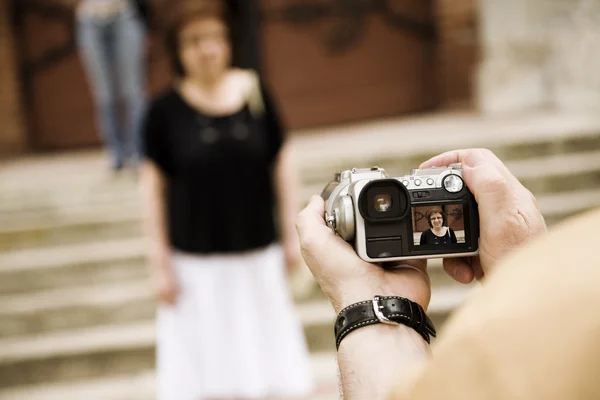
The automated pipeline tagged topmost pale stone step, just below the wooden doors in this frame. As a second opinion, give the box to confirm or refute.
[0,113,600,211]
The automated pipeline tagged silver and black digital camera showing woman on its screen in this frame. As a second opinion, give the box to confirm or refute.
[321,164,479,262]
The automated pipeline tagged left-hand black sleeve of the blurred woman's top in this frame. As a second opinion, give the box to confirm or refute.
[142,100,170,173]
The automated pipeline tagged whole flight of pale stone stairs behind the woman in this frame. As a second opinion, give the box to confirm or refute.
[0,114,600,400]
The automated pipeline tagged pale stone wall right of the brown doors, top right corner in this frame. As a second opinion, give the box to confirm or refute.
[477,0,600,114]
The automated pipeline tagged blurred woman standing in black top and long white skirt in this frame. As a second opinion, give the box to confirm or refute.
[142,0,311,400]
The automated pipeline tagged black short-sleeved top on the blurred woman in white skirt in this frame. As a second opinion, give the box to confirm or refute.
[143,83,284,253]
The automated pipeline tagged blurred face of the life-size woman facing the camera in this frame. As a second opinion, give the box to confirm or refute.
[179,17,231,80]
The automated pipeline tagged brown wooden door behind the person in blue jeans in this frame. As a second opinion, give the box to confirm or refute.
[12,0,170,150]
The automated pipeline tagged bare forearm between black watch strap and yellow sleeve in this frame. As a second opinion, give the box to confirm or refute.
[338,324,431,400]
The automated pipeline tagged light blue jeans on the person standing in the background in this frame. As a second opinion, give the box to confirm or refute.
[77,7,146,169]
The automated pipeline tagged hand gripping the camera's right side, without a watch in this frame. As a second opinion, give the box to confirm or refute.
[420,149,546,283]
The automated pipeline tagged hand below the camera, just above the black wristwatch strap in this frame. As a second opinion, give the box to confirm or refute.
[296,196,431,313]
